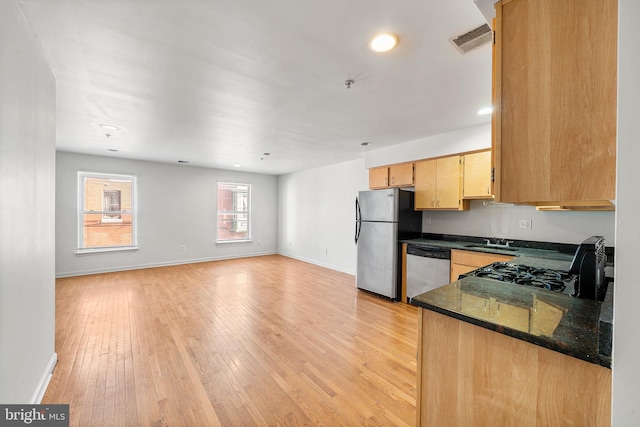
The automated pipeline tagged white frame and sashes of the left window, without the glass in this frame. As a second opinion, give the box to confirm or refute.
[76,171,138,254]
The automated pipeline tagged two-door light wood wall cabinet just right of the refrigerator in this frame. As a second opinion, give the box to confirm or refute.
[415,156,469,210]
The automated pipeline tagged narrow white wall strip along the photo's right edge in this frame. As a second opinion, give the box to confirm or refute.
[613,0,640,426]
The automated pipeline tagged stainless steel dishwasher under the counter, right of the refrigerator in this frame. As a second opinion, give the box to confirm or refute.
[407,245,451,301]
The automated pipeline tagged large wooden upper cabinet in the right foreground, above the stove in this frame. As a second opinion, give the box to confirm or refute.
[493,0,618,206]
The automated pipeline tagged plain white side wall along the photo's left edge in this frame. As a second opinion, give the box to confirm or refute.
[0,0,56,403]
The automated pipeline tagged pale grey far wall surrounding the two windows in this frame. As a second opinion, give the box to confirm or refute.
[56,152,278,277]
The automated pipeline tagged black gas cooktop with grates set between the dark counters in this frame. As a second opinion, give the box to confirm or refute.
[459,262,576,293]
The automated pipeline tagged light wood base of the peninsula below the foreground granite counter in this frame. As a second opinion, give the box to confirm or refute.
[416,308,611,427]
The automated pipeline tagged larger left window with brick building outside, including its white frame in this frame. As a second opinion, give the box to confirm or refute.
[78,172,137,253]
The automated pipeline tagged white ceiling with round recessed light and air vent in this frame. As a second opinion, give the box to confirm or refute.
[18,0,491,175]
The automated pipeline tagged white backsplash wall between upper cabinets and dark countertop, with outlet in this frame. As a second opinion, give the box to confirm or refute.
[422,200,615,246]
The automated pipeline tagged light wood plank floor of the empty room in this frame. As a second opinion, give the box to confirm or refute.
[43,255,418,426]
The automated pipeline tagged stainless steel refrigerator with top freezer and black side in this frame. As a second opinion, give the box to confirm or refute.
[355,188,422,301]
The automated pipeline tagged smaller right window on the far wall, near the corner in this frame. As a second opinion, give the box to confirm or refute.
[216,182,251,243]
